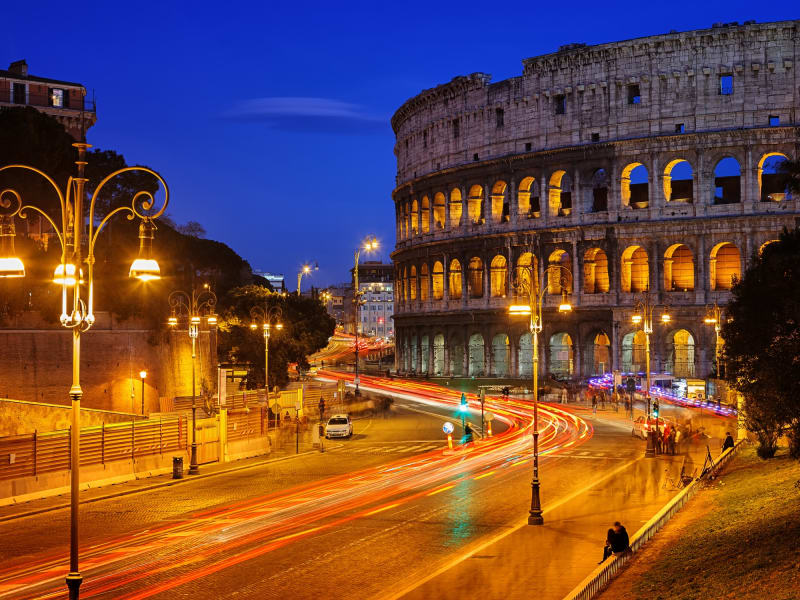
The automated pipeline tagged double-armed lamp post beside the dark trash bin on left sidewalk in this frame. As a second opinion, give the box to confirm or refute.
[168,282,217,475]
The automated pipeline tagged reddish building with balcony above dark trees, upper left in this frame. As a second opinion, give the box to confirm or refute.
[0,60,97,140]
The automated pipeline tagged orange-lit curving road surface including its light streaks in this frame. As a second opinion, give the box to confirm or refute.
[0,377,612,600]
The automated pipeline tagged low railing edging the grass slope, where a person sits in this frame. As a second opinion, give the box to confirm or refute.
[564,441,743,600]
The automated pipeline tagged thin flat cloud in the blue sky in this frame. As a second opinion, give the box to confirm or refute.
[223,97,389,133]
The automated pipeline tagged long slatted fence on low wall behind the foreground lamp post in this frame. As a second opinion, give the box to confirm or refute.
[0,417,186,481]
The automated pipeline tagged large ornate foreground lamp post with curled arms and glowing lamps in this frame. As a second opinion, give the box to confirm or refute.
[0,142,169,600]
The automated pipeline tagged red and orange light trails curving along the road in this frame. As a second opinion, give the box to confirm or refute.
[0,372,592,600]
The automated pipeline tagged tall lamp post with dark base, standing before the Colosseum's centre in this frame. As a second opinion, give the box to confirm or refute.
[508,261,572,525]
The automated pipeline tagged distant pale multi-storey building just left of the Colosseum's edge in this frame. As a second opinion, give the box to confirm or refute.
[350,261,394,337]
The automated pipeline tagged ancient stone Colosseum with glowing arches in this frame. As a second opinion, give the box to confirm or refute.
[392,21,800,384]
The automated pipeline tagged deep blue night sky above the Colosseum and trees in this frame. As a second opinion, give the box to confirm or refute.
[0,1,798,287]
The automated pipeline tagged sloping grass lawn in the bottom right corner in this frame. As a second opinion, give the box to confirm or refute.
[600,447,800,600]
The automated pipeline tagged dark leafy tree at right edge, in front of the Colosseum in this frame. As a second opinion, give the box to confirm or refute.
[722,230,800,458]
